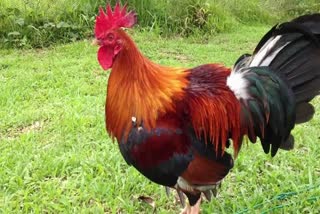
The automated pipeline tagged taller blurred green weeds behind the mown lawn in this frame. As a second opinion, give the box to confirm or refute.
[0,0,320,48]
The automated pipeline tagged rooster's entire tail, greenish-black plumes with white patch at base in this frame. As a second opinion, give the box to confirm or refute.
[227,14,320,156]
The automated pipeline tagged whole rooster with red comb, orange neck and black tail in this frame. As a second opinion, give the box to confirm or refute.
[94,3,320,213]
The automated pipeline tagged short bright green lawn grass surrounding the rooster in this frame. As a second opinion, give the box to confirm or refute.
[0,26,320,213]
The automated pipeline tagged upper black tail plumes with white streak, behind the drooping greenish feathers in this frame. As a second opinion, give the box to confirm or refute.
[248,14,320,123]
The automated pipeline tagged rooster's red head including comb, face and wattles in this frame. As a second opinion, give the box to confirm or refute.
[94,2,137,70]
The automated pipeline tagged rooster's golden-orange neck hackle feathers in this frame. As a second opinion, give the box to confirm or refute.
[105,31,188,142]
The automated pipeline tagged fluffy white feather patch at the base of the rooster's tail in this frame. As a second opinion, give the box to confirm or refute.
[227,71,250,99]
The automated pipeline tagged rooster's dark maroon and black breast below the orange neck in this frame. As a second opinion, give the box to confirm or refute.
[119,114,194,187]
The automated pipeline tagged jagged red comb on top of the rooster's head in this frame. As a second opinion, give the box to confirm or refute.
[94,2,137,38]
